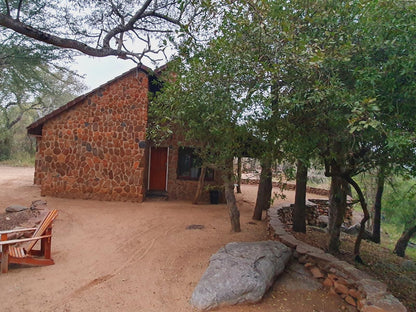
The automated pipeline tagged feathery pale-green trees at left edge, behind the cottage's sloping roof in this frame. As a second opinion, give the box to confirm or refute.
[0,32,84,158]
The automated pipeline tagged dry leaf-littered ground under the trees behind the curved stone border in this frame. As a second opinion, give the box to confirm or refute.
[293,227,416,311]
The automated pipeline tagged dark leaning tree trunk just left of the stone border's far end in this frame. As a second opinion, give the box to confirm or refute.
[253,160,273,220]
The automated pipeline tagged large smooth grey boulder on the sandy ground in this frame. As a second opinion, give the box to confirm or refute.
[191,241,292,310]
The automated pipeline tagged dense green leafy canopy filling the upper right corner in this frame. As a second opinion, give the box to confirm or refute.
[256,0,416,255]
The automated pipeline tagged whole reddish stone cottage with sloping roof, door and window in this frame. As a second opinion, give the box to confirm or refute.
[27,66,221,202]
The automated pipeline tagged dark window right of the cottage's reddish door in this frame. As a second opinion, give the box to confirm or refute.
[177,147,214,181]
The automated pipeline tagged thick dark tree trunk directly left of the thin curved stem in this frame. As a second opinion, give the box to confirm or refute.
[328,176,348,253]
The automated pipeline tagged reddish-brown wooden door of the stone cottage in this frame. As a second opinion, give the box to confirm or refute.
[149,147,168,191]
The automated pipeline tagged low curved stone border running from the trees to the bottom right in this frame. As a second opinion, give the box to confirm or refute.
[267,205,407,312]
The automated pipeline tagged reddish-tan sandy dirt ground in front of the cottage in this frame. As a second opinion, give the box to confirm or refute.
[0,167,352,312]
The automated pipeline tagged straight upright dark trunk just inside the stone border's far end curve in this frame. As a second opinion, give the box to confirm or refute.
[293,160,308,233]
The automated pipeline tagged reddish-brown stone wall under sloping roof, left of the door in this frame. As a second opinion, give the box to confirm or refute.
[35,70,148,201]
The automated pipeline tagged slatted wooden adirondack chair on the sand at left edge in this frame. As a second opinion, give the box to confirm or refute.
[0,209,58,273]
